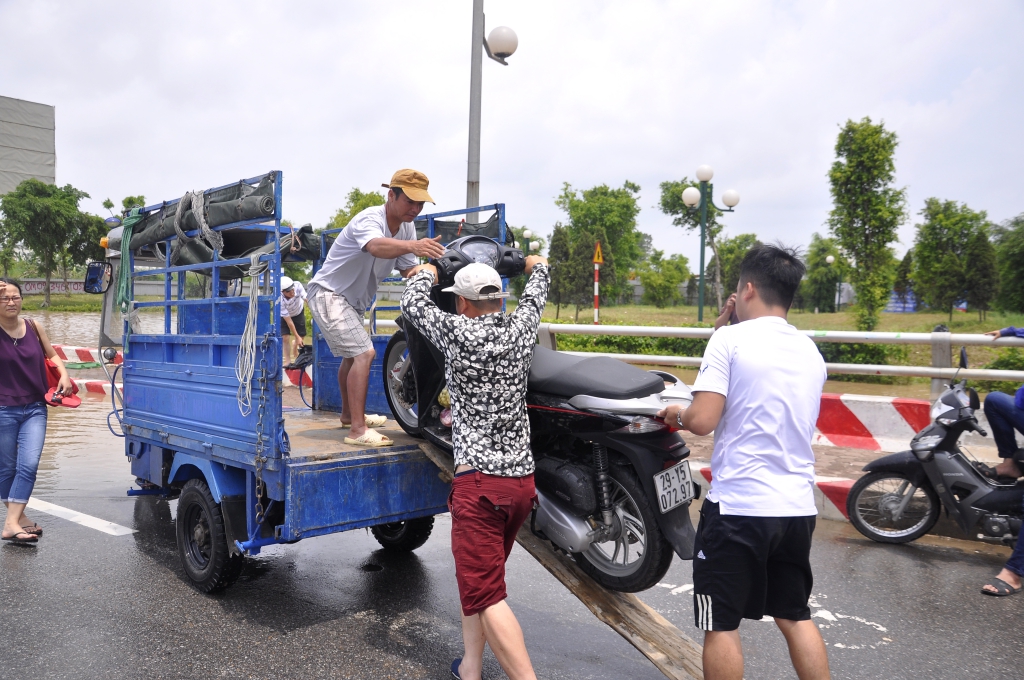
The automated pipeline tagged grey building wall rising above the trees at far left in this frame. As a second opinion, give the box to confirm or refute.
[0,96,57,196]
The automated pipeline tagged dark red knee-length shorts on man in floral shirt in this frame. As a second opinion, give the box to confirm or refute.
[449,471,537,617]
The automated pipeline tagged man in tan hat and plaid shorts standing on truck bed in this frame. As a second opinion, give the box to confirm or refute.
[306,169,444,447]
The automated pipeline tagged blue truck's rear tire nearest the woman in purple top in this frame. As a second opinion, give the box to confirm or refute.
[175,479,246,593]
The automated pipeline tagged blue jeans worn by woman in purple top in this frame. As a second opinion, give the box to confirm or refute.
[0,401,46,503]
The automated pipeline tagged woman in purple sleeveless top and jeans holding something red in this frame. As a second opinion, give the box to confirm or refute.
[0,279,72,545]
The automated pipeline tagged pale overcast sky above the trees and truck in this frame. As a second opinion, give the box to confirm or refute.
[0,0,1024,267]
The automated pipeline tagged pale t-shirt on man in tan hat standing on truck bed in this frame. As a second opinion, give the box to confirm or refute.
[309,206,418,313]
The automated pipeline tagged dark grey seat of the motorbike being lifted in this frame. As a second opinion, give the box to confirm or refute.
[526,345,665,399]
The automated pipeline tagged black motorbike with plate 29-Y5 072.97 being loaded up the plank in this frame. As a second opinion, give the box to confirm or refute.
[383,236,700,592]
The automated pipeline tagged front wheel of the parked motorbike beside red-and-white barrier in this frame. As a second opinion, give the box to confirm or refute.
[846,472,940,543]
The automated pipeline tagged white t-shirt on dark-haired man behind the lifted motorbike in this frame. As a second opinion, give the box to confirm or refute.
[693,316,825,517]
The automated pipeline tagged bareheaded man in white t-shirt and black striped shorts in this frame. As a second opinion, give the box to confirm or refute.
[659,245,829,680]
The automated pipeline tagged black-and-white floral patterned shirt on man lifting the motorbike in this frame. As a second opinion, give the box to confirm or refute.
[401,264,551,477]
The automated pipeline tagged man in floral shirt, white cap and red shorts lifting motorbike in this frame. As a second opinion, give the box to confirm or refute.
[401,256,551,680]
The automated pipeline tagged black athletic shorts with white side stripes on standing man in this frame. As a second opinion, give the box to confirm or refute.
[693,501,815,631]
